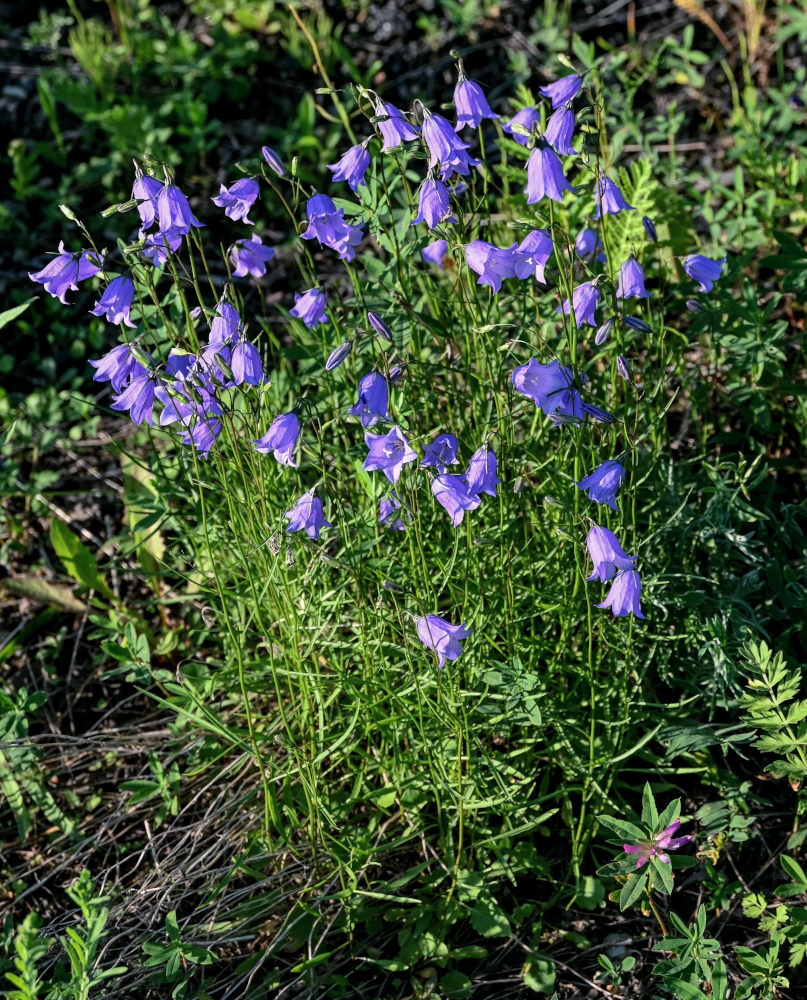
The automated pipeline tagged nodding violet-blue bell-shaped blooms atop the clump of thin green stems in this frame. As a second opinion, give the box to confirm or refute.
[30,56,726,680]
